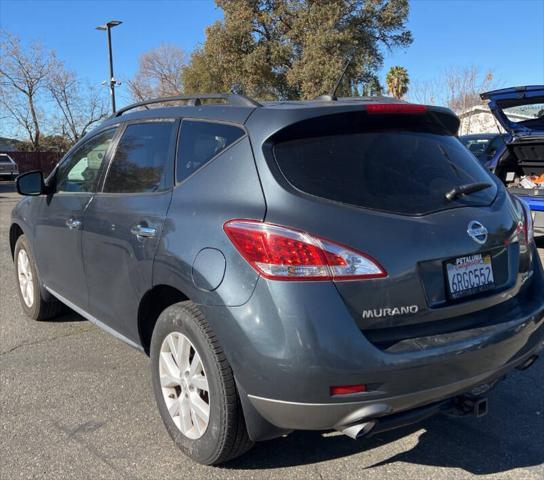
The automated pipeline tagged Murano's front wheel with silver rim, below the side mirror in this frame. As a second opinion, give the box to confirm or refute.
[13,235,64,320]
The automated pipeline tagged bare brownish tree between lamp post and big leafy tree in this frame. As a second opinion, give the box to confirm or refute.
[128,44,185,101]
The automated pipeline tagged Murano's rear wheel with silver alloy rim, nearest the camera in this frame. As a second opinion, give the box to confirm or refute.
[150,302,253,465]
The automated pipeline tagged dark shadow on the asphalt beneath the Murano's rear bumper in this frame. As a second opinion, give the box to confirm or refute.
[223,361,544,475]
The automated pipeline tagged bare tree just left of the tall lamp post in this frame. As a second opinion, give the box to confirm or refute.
[47,63,108,143]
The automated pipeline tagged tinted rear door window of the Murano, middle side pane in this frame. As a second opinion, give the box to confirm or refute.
[103,122,176,193]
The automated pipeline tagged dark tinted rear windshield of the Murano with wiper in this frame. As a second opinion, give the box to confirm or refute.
[273,124,497,215]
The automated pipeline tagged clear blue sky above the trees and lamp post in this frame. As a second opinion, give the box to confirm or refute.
[0,0,544,109]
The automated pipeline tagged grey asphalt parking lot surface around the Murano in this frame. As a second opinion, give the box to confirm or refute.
[0,182,544,480]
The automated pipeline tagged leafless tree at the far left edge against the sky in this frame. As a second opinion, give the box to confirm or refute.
[0,32,56,150]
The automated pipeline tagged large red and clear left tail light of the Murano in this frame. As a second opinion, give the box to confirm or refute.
[223,220,387,280]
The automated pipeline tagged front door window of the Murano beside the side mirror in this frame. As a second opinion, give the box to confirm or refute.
[56,128,116,192]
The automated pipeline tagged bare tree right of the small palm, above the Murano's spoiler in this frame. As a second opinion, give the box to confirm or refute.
[444,66,494,112]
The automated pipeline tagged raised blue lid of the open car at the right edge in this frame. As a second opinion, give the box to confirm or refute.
[480,85,544,136]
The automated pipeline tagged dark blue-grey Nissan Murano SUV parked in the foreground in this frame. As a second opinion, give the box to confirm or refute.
[10,95,544,464]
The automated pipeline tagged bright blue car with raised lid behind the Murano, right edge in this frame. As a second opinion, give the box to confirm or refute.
[481,85,544,234]
